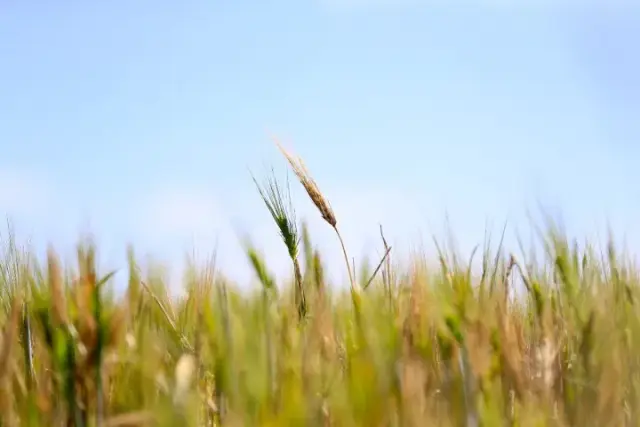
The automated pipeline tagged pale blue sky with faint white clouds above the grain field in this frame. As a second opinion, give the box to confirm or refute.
[0,0,640,290]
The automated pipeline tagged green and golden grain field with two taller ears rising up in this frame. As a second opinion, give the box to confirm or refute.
[0,148,640,427]
